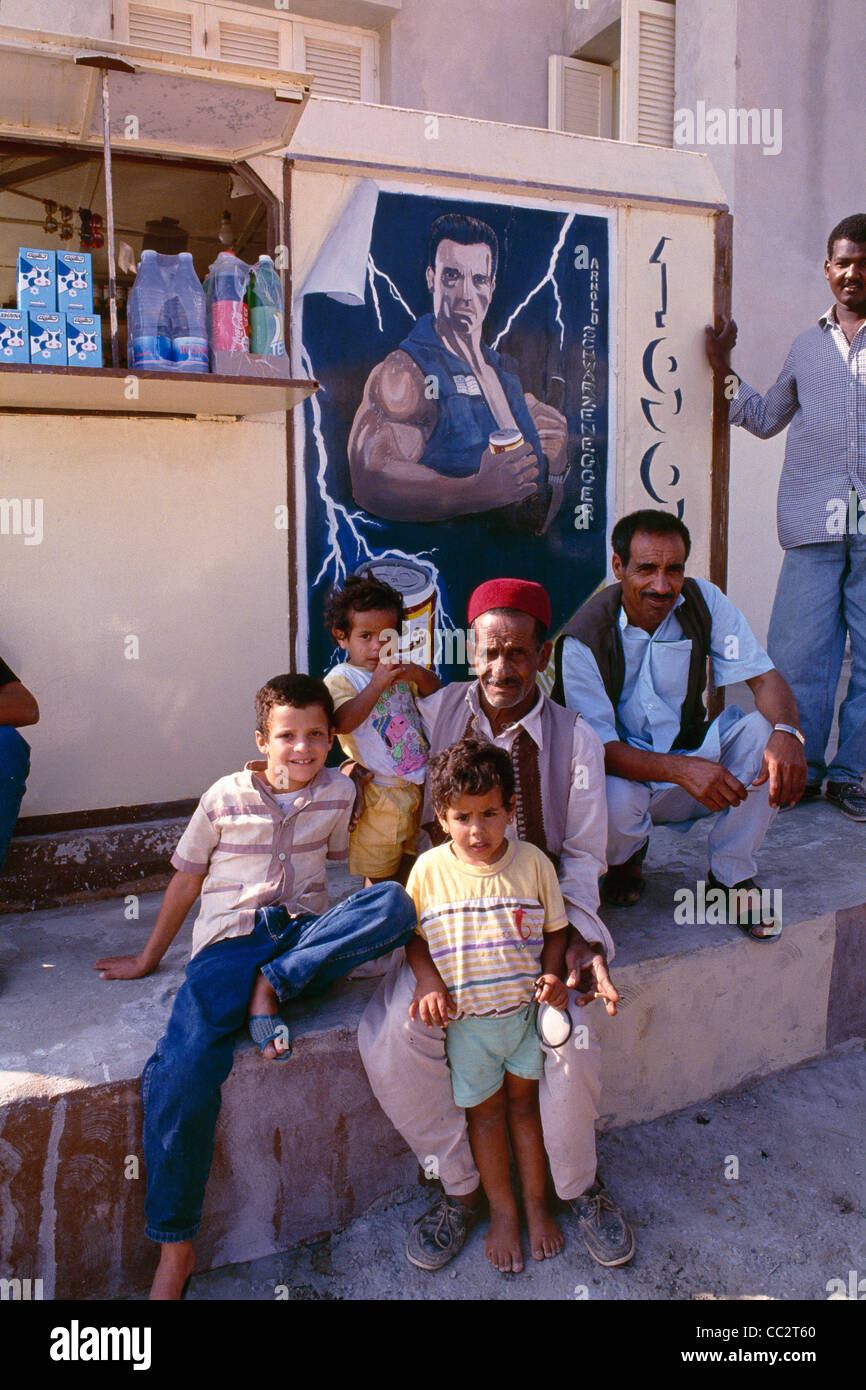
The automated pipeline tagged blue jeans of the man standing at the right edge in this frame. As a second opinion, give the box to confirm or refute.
[767,535,866,785]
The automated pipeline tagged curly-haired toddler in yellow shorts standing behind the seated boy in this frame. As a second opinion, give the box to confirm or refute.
[325,574,441,887]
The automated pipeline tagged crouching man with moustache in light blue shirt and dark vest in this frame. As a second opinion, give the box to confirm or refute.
[560,510,806,940]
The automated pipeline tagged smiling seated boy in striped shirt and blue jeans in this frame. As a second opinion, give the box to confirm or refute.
[96,674,414,1298]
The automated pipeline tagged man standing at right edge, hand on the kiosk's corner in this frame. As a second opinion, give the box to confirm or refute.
[706,213,866,821]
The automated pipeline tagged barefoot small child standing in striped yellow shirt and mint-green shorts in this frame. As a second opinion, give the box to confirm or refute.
[406,738,569,1273]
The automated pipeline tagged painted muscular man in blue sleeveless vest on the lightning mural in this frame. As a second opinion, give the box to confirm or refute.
[349,213,569,534]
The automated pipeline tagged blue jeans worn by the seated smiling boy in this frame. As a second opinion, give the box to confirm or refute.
[142,883,416,1243]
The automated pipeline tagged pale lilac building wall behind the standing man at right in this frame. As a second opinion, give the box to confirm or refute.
[677,0,866,639]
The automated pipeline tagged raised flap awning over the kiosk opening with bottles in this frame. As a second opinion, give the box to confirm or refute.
[0,26,313,163]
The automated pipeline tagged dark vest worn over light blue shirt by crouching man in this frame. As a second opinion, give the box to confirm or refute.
[552,580,712,749]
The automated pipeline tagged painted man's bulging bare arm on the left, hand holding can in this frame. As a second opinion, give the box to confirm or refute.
[349,349,538,521]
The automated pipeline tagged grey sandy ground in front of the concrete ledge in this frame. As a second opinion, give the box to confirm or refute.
[155,1044,866,1301]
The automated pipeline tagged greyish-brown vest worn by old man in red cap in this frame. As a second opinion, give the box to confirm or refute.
[421,681,580,863]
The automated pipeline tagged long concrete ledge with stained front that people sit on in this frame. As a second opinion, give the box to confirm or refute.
[0,805,866,1298]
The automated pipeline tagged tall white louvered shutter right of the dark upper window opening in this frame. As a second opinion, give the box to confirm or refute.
[620,0,676,145]
